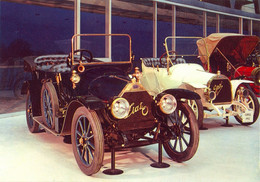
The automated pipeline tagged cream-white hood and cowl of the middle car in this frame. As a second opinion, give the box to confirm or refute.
[140,63,216,95]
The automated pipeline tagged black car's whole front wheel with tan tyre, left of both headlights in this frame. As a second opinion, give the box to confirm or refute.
[71,106,104,175]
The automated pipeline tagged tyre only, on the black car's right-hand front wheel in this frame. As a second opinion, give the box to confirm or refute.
[163,102,199,162]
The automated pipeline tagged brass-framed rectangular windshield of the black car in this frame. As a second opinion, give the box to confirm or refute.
[71,34,131,64]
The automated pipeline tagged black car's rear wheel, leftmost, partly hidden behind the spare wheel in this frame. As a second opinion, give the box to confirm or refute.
[26,91,39,133]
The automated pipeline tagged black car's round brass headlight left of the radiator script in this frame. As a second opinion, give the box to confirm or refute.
[111,98,130,119]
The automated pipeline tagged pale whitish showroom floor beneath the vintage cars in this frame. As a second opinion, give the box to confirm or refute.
[0,103,260,182]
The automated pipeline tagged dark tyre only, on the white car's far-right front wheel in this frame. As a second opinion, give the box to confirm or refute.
[233,89,259,126]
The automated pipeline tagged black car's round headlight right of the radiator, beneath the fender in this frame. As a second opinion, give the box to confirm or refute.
[159,94,177,114]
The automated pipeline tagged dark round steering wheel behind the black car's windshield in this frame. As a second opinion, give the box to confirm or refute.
[67,49,93,67]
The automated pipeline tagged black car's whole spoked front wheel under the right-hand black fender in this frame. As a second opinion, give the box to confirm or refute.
[163,102,199,162]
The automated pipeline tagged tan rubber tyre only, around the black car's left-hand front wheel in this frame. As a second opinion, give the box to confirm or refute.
[71,106,104,176]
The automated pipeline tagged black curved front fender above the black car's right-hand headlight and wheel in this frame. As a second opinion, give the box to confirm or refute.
[161,88,200,100]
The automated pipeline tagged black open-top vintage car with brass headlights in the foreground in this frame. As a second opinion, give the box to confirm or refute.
[22,34,199,175]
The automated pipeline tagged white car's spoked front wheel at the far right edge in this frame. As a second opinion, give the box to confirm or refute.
[233,89,259,126]
